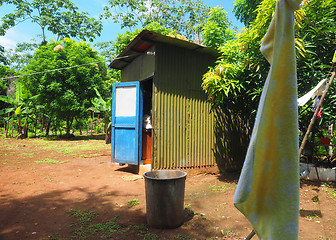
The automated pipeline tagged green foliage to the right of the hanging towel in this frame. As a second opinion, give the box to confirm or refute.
[297,0,336,137]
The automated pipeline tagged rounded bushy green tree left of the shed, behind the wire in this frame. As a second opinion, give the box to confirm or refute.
[22,38,107,134]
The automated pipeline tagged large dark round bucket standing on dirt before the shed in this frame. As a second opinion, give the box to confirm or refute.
[143,170,187,228]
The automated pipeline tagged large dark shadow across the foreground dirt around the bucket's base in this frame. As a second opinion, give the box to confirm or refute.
[0,187,218,240]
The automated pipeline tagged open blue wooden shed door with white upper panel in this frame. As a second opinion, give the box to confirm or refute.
[111,82,142,165]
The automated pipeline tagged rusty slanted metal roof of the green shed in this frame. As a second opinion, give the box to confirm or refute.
[109,30,218,69]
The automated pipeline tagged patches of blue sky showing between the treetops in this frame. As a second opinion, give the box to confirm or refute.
[0,0,244,49]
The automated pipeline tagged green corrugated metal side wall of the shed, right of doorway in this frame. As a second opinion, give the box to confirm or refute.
[152,44,216,169]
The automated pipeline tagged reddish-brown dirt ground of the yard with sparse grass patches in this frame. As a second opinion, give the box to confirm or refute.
[0,137,336,240]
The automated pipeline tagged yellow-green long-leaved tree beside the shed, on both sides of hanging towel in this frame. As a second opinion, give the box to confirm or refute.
[203,0,336,146]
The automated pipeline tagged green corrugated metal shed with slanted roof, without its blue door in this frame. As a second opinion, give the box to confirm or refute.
[110,30,242,169]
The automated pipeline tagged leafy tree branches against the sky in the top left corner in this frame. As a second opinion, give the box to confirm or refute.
[0,0,102,43]
